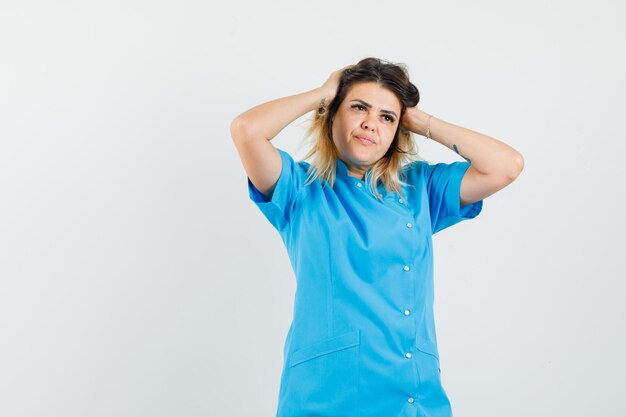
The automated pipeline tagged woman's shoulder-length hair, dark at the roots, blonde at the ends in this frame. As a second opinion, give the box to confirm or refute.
[303,57,422,200]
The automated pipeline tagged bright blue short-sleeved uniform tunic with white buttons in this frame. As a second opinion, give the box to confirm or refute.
[248,148,483,417]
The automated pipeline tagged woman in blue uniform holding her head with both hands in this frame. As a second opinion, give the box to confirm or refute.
[231,58,523,417]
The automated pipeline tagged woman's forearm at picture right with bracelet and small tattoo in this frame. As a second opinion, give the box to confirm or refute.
[411,110,524,179]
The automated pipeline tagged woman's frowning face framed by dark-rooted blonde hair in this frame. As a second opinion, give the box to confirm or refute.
[332,82,402,179]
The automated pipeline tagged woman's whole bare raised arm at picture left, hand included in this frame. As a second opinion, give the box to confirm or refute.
[230,65,350,198]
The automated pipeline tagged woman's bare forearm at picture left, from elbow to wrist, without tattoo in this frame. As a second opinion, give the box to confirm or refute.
[230,88,328,140]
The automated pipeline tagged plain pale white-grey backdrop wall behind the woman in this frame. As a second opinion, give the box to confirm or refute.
[0,0,626,417]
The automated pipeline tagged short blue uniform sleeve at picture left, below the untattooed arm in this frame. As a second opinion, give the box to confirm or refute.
[247,148,300,232]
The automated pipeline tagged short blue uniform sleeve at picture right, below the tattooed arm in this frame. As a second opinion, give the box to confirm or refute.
[423,161,483,234]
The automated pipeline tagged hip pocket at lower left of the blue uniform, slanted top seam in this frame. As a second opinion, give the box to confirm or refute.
[285,330,360,417]
